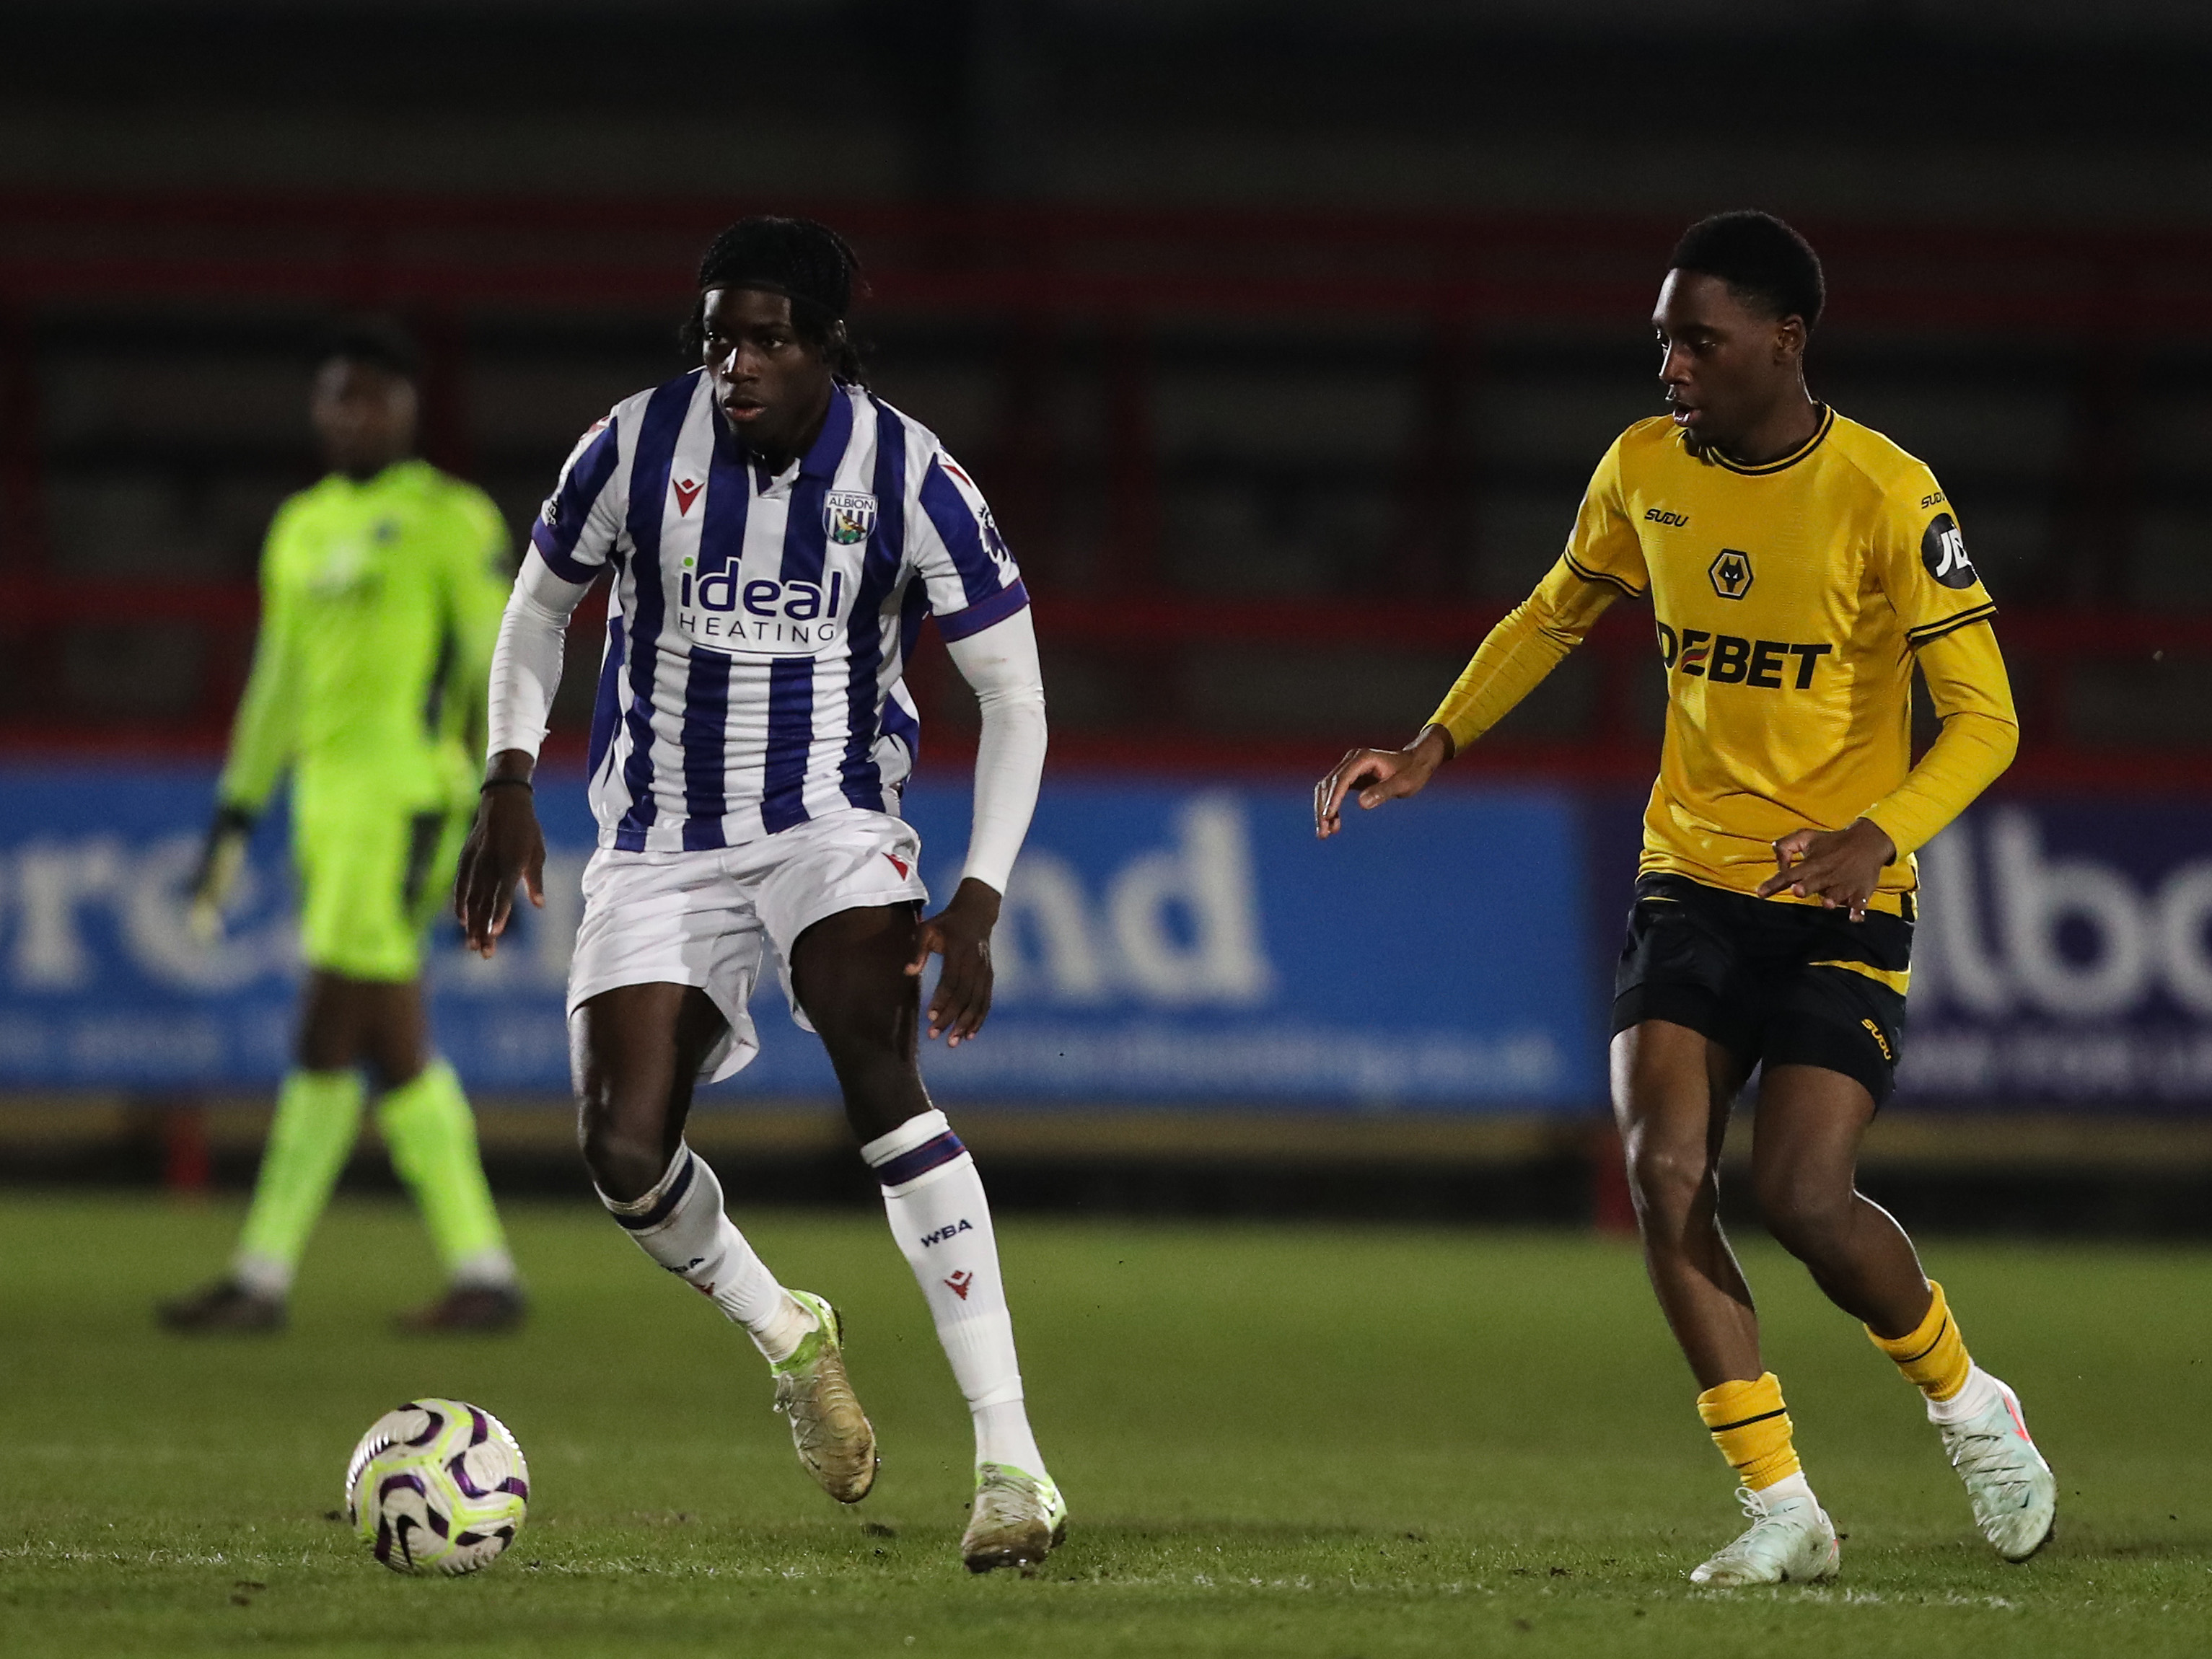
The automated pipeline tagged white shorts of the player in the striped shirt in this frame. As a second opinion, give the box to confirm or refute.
[569,807,929,1082]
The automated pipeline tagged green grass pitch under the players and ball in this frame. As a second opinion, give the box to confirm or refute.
[0,1194,2212,1659]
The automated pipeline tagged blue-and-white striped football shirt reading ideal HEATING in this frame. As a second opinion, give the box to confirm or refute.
[531,369,1029,852]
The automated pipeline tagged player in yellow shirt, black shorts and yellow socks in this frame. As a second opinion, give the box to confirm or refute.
[1314,212,2057,1586]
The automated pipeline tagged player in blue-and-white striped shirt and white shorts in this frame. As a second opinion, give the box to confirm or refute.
[456,219,1066,1572]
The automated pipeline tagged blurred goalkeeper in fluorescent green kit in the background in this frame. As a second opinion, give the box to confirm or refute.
[159,323,522,1332]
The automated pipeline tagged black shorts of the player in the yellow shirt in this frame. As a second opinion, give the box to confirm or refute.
[1612,876,1913,1106]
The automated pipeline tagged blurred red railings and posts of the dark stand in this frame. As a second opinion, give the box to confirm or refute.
[0,193,2212,790]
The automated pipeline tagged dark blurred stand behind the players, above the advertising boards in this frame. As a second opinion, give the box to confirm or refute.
[0,0,2212,1220]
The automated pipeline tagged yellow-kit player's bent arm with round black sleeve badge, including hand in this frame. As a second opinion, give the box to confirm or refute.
[1758,469,2019,920]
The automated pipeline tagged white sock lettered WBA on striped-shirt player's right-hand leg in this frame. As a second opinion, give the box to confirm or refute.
[861,1110,1044,1475]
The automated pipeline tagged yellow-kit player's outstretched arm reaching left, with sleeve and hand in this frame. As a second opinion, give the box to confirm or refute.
[1314,442,1650,840]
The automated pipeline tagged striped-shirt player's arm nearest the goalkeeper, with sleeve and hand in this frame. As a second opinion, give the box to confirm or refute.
[454,416,626,956]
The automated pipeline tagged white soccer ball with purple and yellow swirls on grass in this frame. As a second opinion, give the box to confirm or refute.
[345,1400,531,1575]
